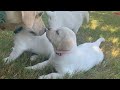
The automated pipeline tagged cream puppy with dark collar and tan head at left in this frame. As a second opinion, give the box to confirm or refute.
[4,11,53,63]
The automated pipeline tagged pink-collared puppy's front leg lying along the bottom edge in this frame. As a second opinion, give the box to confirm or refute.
[39,73,63,79]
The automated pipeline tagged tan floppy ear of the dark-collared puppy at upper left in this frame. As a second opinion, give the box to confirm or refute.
[22,11,36,29]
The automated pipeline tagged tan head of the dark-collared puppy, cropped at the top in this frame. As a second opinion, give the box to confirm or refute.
[22,11,46,35]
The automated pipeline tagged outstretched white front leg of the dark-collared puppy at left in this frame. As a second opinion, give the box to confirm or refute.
[4,47,25,64]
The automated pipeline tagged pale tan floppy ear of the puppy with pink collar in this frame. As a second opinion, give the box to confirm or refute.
[57,39,74,51]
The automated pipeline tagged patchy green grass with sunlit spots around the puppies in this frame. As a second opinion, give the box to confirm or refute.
[0,11,120,79]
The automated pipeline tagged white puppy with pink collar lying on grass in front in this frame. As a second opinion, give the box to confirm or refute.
[26,27,105,79]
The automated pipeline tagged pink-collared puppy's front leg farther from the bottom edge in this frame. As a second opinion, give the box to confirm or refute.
[26,60,50,70]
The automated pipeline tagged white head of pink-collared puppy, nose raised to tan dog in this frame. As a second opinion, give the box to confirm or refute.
[46,27,76,51]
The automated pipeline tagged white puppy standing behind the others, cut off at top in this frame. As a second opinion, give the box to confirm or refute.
[46,11,89,33]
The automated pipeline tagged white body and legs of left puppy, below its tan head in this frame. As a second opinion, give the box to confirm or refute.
[4,27,54,64]
